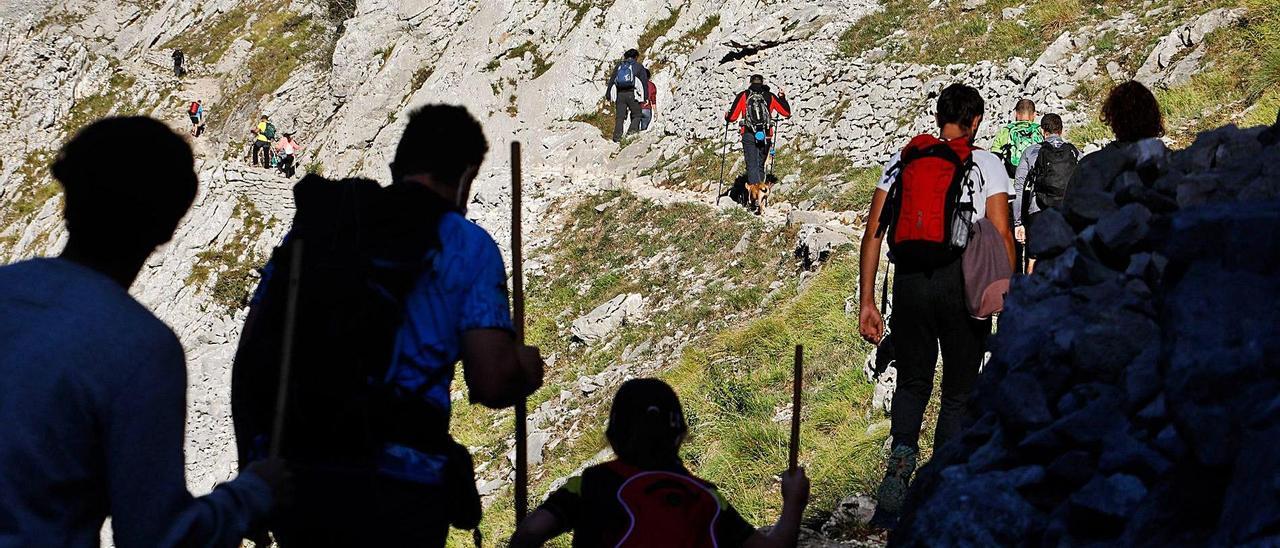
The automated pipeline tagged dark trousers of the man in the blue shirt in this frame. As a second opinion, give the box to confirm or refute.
[271,470,449,548]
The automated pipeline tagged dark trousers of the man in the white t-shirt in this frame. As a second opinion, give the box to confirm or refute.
[890,260,991,449]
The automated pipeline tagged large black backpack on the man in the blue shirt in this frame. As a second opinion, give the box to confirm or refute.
[232,175,452,469]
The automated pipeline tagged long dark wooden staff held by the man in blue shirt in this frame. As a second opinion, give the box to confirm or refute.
[511,141,529,528]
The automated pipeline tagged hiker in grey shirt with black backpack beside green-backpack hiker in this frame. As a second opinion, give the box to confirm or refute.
[1014,114,1080,273]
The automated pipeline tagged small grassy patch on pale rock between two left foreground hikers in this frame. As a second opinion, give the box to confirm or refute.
[184,195,275,309]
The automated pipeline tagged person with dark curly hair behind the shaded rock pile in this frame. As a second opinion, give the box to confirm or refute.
[1075,81,1169,190]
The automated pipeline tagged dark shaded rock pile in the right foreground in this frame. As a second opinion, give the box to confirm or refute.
[891,122,1280,545]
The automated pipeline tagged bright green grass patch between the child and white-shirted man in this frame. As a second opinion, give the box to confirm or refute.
[663,255,887,526]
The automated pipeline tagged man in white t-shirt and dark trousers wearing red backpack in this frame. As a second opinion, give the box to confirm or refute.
[859,85,1014,528]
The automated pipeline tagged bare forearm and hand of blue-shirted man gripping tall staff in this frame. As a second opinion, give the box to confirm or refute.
[462,329,543,408]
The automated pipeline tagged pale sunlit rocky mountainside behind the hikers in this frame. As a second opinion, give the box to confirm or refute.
[0,0,1269,540]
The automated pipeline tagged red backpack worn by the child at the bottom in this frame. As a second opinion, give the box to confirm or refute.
[609,461,721,548]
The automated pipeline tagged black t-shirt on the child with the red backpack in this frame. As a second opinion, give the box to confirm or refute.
[540,461,755,548]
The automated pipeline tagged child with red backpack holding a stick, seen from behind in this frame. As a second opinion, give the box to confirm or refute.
[511,379,809,548]
